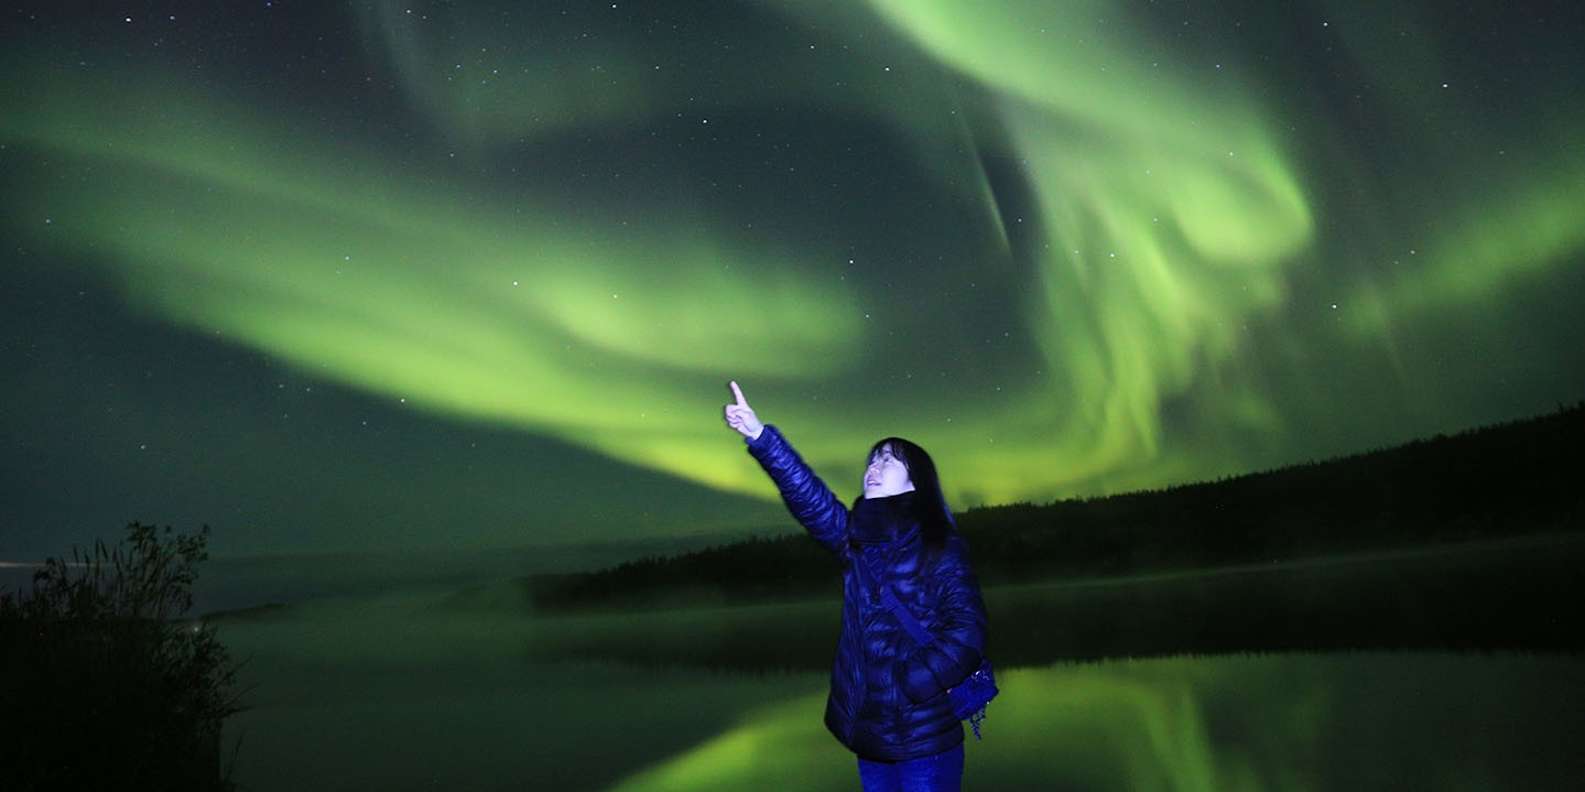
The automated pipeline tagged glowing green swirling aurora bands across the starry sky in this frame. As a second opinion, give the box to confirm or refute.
[0,0,1585,519]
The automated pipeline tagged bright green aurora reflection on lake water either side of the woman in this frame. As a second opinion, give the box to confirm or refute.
[602,654,1585,792]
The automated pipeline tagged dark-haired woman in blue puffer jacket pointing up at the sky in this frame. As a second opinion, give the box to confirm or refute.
[726,382,986,792]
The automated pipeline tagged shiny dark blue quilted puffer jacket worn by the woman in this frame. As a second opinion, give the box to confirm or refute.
[747,425,986,762]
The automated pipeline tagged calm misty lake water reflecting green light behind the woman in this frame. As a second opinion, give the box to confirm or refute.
[219,583,1585,792]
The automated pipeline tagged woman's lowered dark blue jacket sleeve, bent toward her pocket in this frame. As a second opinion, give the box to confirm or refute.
[896,539,986,703]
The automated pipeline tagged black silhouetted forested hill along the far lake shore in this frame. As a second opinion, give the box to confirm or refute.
[523,402,1585,610]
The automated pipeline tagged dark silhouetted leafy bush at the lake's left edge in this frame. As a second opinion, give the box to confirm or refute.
[0,523,241,792]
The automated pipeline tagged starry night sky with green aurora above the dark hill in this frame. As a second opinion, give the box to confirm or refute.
[0,0,1585,561]
